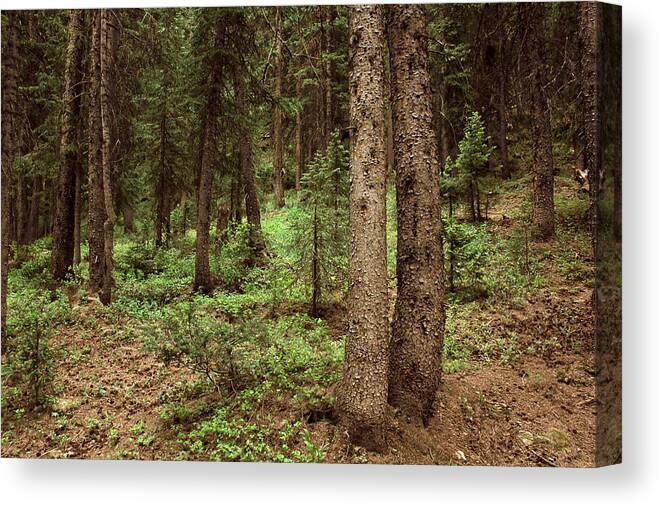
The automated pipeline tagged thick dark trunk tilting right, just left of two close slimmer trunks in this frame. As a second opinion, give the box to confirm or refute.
[51,9,83,280]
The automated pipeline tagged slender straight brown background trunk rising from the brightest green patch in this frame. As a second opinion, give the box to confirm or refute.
[273,7,285,208]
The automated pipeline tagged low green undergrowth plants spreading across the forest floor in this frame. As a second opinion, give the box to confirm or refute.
[2,175,591,462]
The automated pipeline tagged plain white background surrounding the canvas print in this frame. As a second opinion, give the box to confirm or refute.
[0,0,661,507]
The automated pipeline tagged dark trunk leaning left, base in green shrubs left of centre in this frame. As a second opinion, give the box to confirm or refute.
[234,69,264,257]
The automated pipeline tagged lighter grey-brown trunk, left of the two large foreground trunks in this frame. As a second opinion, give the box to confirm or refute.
[336,5,389,450]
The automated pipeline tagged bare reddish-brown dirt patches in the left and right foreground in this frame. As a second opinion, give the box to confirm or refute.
[2,324,596,467]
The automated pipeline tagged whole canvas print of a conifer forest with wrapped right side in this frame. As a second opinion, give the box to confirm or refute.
[1,2,622,467]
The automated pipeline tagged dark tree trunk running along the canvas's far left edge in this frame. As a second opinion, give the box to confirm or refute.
[0,11,18,337]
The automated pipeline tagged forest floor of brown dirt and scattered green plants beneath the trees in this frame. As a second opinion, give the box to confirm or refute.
[2,178,596,467]
